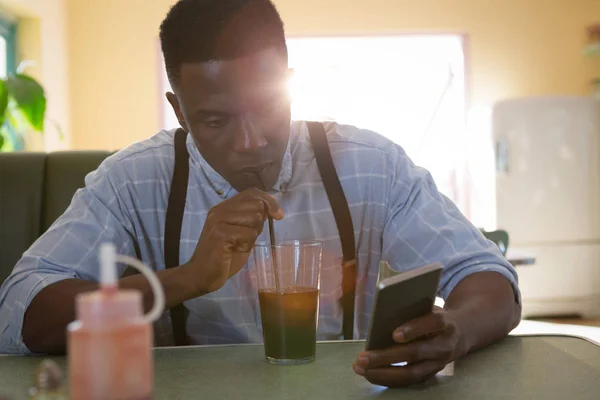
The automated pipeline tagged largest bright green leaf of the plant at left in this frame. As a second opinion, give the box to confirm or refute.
[6,74,46,132]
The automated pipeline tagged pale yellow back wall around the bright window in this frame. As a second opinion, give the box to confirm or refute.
[67,0,600,149]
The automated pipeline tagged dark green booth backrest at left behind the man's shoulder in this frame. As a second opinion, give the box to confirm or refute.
[0,151,110,284]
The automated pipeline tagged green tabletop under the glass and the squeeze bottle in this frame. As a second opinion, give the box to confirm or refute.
[0,336,600,400]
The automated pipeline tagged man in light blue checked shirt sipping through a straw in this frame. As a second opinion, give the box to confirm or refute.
[0,0,520,386]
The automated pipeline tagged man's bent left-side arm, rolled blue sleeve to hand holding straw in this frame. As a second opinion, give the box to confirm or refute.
[0,143,283,353]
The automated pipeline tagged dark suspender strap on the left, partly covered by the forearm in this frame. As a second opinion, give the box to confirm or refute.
[164,129,190,346]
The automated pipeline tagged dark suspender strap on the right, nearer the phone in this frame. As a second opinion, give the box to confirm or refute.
[307,122,357,340]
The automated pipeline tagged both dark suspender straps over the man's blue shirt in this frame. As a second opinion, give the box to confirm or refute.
[164,122,357,346]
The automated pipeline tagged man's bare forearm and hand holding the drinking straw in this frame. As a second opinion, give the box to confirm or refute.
[18,184,283,353]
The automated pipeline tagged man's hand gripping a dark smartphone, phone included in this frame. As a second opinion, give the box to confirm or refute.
[353,264,461,387]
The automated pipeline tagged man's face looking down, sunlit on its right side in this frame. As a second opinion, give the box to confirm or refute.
[167,48,291,192]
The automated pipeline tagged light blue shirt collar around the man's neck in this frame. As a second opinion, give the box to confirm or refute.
[186,125,298,197]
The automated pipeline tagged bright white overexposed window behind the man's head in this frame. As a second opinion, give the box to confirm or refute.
[163,35,494,226]
